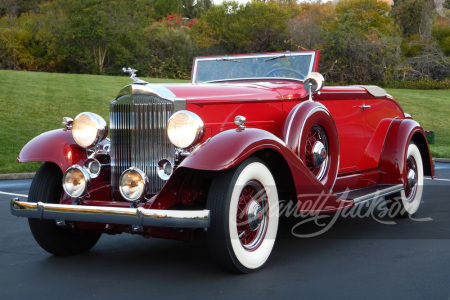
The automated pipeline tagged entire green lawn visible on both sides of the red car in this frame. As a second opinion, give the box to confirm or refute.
[0,70,450,173]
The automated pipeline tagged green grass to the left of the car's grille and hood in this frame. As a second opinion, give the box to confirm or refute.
[0,70,186,174]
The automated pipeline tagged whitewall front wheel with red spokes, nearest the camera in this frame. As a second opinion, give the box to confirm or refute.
[207,158,279,273]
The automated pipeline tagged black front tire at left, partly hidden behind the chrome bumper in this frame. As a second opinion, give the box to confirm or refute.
[28,162,101,256]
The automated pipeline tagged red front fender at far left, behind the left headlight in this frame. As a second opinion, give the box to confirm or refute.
[17,129,87,172]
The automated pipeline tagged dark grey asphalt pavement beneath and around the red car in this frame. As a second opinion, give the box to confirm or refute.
[0,163,450,300]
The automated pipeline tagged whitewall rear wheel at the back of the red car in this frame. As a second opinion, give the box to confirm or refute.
[385,143,423,218]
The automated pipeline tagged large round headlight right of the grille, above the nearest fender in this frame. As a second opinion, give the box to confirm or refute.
[167,110,204,148]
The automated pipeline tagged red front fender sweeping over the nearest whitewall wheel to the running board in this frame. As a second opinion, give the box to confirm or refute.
[179,128,353,213]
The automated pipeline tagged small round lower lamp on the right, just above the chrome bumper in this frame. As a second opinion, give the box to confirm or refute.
[119,168,148,201]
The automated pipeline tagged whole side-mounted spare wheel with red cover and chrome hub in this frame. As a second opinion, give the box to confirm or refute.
[283,101,339,190]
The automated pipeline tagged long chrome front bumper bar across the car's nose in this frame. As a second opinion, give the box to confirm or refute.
[11,198,209,228]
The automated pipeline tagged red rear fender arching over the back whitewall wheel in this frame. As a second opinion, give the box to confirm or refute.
[380,119,434,184]
